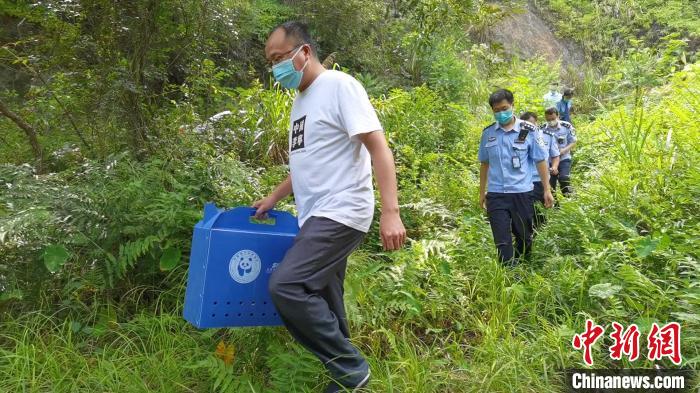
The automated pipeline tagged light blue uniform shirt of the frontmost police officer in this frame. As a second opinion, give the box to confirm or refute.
[478,119,547,194]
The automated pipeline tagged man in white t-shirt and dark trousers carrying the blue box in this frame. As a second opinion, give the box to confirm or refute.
[253,22,406,392]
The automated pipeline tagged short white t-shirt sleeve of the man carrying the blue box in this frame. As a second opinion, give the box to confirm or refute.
[337,77,383,137]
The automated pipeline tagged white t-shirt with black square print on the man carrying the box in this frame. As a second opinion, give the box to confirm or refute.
[289,70,382,232]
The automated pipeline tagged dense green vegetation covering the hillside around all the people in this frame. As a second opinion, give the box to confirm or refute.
[0,0,700,392]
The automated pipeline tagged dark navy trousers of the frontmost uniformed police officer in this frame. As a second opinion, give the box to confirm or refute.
[486,192,535,265]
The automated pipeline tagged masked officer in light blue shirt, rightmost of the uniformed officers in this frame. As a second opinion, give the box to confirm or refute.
[543,108,576,196]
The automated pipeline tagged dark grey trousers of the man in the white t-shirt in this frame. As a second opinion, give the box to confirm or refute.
[269,217,369,387]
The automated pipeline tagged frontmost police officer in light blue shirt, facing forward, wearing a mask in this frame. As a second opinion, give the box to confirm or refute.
[478,89,554,265]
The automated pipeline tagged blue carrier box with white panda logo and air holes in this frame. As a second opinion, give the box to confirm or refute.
[184,203,299,328]
